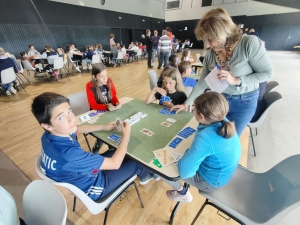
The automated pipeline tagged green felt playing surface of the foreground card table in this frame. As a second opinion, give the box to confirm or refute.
[88,99,193,163]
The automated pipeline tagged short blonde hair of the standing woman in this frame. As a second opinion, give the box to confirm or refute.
[194,8,240,46]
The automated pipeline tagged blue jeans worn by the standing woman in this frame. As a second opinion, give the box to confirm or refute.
[222,89,259,136]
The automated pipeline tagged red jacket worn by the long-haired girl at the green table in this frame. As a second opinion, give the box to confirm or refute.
[86,78,119,111]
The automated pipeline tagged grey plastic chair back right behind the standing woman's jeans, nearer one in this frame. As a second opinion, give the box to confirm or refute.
[248,91,282,128]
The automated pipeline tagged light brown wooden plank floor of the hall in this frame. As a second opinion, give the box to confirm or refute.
[0,51,249,225]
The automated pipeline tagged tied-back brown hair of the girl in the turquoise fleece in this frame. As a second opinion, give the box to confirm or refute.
[194,92,235,138]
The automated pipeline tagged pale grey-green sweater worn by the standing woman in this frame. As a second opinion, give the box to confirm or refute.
[185,35,274,105]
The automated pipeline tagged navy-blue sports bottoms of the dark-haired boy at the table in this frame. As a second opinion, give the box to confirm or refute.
[99,151,149,199]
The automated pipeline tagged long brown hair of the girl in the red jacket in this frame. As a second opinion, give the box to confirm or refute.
[91,63,112,104]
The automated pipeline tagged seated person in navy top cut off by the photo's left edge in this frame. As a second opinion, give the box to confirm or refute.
[0,47,18,95]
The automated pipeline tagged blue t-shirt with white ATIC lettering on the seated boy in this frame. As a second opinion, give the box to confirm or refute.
[41,132,105,200]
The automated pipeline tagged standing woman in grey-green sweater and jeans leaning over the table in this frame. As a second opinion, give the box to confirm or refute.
[171,8,274,136]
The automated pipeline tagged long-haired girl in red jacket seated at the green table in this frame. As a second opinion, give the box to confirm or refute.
[86,63,122,154]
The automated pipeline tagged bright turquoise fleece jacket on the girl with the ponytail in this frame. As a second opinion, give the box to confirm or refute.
[178,122,241,188]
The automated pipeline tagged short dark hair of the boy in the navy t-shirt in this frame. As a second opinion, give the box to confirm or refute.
[31,92,70,125]
